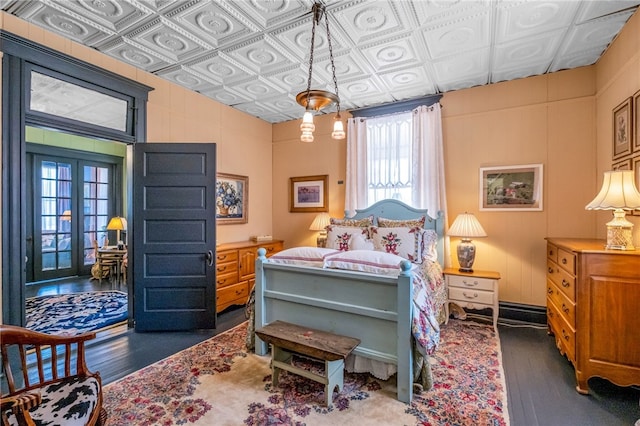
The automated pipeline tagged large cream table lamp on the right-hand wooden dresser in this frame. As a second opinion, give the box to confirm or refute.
[585,170,640,250]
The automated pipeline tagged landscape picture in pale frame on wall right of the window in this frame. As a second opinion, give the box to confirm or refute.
[480,164,542,211]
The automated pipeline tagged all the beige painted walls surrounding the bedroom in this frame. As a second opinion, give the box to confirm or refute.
[0,9,640,306]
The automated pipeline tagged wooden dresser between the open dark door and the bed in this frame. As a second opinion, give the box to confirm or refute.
[216,240,284,312]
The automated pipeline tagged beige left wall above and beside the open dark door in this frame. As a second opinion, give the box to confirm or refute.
[0,12,273,243]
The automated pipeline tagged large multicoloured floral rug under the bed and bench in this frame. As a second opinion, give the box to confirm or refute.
[104,320,509,426]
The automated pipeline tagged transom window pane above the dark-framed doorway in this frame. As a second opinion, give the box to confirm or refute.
[29,71,127,131]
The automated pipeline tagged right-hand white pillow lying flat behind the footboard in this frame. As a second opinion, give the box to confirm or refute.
[324,250,417,277]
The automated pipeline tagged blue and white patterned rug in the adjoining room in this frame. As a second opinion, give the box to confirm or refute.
[26,291,127,336]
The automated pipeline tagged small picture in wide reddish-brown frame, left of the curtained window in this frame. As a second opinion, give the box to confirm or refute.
[289,175,329,212]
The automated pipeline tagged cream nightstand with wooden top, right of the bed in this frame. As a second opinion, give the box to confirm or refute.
[443,268,500,331]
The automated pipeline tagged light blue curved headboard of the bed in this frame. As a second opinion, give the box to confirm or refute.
[349,199,444,265]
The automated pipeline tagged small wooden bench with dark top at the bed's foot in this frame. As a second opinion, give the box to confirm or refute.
[256,321,360,407]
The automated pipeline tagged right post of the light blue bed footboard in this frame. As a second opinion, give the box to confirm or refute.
[397,260,413,404]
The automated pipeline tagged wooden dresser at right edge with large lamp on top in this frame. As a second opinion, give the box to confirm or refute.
[547,238,640,394]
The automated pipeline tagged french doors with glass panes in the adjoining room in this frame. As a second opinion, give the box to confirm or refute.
[27,154,120,282]
